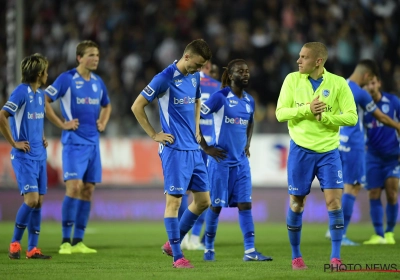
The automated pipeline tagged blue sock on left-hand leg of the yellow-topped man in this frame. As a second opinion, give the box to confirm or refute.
[286,207,303,259]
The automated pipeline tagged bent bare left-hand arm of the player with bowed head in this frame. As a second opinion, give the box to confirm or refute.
[131,95,174,145]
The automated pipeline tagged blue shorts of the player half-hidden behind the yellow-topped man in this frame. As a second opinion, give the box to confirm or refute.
[339,151,365,185]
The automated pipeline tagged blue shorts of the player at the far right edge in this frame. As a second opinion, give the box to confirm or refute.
[365,152,400,190]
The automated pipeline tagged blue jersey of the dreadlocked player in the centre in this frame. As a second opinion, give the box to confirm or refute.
[201,87,254,166]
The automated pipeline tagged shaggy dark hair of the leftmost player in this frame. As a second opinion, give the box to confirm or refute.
[21,53,49,83]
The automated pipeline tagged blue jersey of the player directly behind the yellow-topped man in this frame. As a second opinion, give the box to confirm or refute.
[339,80,377,152]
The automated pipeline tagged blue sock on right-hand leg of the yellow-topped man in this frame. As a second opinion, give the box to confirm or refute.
[328,209,344,259]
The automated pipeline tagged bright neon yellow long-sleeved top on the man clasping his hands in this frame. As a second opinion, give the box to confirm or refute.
[276,69,358,153]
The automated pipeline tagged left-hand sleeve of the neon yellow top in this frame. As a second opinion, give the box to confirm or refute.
[275,74,312,122]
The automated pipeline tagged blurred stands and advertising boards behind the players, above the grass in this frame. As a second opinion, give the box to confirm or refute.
[0,0,400,222]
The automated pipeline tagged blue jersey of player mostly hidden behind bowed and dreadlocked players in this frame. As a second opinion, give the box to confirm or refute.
[200,72,221,145]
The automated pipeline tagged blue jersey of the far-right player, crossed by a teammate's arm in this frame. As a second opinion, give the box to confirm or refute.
[364,92,400,156]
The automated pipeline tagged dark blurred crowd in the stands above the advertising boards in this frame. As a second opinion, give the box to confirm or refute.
[0,0,400,137]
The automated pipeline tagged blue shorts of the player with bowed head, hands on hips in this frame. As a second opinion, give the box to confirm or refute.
[159,144,210,195]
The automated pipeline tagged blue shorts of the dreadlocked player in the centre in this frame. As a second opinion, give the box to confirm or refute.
[208,158,252,207]
